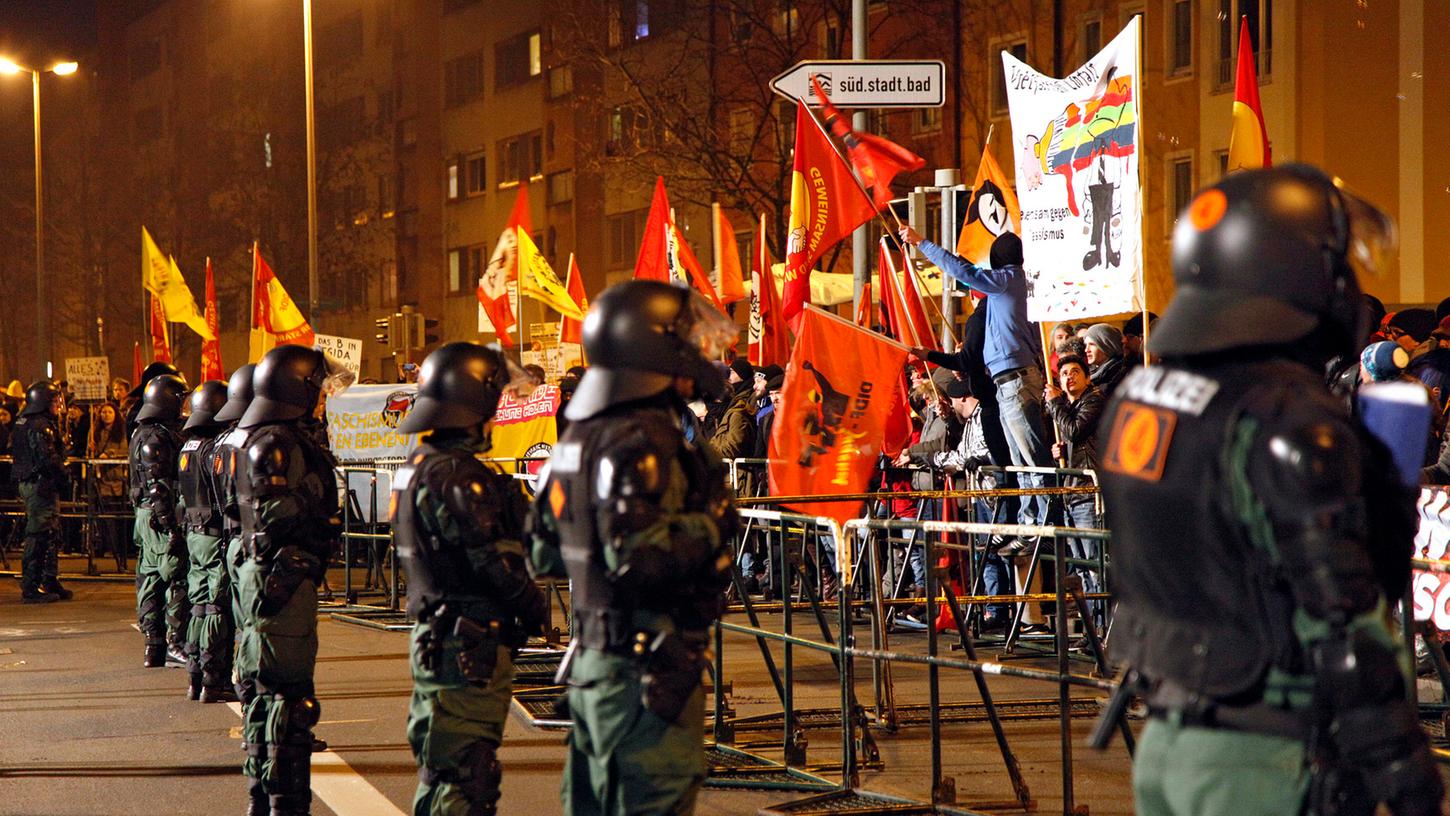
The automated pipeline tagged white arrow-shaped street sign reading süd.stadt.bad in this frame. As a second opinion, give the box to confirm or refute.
[770,59,947,107]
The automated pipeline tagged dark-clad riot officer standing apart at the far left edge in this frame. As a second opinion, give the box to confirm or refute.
[10,380,71,603]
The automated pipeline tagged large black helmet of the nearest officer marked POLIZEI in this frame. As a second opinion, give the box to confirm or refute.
[1148,164,1395,357]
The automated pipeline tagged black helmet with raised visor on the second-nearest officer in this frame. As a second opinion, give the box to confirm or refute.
[564,281,738,422]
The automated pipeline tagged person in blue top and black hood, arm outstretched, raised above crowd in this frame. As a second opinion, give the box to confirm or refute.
[900,226,1051,525]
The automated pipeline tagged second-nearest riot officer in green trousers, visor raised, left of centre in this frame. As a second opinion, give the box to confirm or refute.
[531,281,738,816]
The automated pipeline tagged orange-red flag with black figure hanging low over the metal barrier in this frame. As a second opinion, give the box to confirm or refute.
[770,309,906,547]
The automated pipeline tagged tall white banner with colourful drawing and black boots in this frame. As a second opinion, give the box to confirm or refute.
[1002,16,1143,322]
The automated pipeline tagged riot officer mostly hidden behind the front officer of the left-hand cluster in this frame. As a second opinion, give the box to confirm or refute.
[212,362,257,706]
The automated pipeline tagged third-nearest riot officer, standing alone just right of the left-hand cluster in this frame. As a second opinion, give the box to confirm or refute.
[392,342,548,816]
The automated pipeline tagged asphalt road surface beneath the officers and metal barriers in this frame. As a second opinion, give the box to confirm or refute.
[0,581,1132,816]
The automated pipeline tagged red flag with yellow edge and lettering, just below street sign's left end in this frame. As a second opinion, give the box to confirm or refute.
[782,100,876,325]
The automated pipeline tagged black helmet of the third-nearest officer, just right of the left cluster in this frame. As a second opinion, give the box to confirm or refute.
[397,342,509,433]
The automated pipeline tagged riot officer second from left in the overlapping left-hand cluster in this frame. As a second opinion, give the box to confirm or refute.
[177,380,232,703]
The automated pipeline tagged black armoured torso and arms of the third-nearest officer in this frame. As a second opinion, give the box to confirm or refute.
[392,444,545,630]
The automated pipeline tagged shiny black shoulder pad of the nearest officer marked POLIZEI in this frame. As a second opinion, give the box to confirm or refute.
[1264,416,1364,506]
